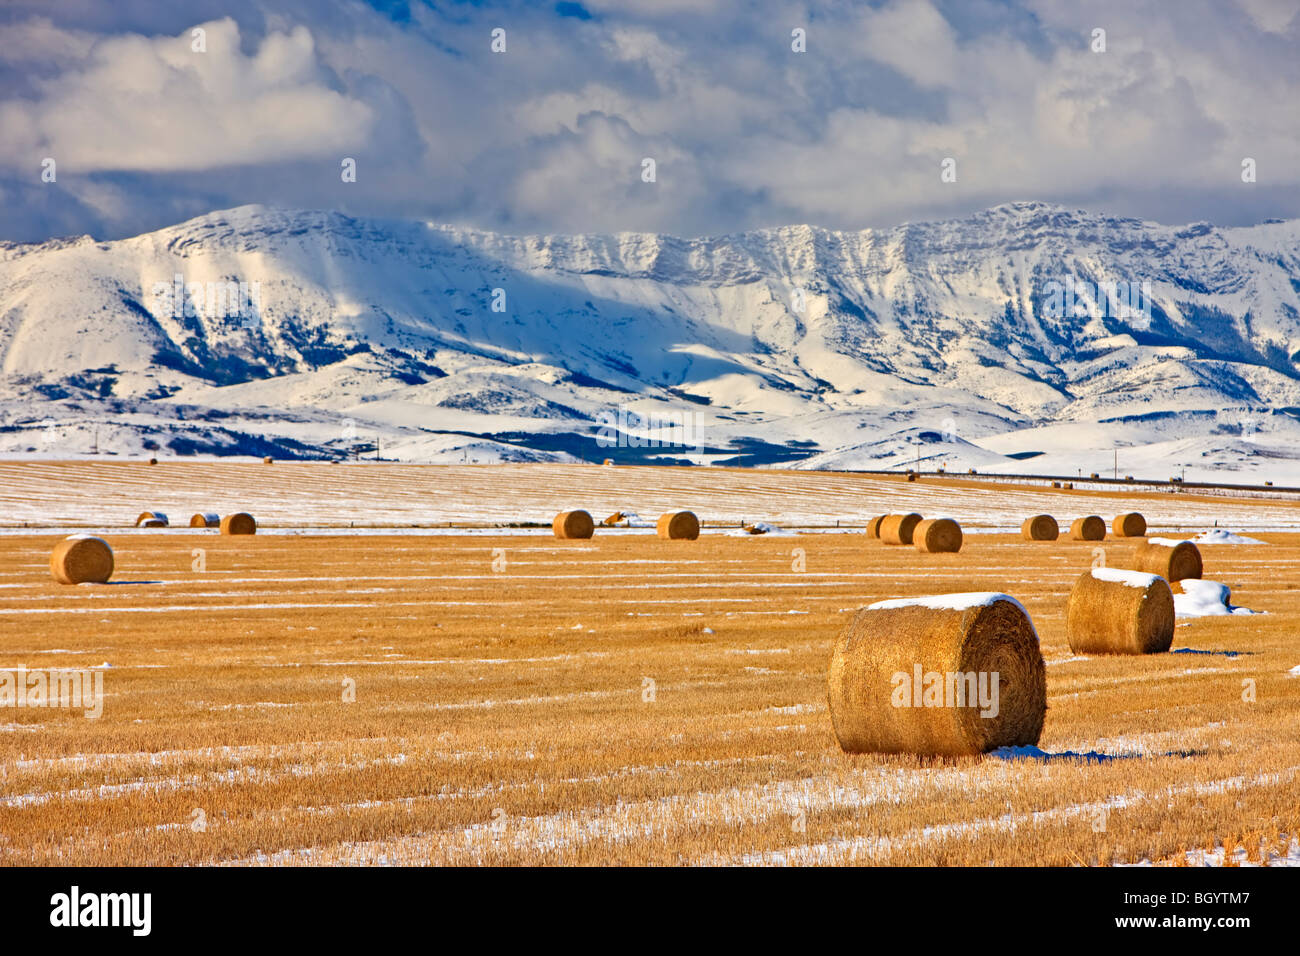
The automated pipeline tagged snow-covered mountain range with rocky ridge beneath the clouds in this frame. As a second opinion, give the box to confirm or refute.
[0,203,1300,480]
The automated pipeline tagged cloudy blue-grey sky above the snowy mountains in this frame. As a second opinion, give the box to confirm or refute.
[0,0,1300,241]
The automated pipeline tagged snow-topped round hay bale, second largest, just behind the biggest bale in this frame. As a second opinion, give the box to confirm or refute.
[1065,567,1174,654]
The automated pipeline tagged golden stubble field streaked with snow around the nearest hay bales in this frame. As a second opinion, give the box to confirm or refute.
[0,463,1300,865]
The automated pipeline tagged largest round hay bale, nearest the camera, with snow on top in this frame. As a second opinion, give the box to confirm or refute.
[827,593,1047,756]
